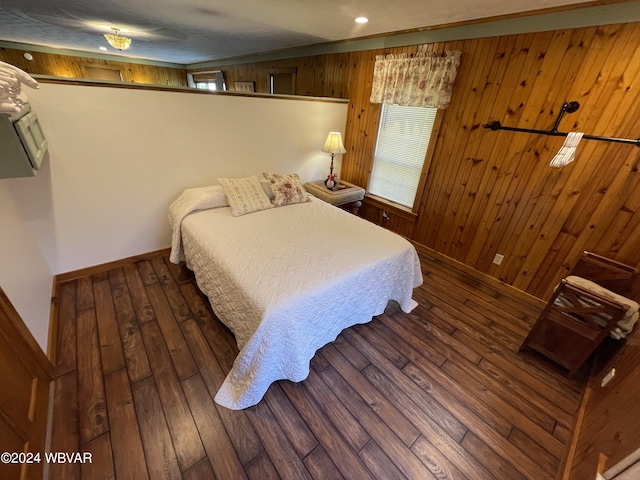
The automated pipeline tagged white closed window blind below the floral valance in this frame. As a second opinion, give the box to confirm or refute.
[369,104,438,208]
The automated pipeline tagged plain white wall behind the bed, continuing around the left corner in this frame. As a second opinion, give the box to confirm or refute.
[0,83,347,348]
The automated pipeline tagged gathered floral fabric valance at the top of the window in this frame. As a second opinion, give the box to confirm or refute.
[371,50,461,109]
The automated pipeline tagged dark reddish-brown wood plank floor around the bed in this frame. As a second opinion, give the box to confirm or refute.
[50,248,582,480]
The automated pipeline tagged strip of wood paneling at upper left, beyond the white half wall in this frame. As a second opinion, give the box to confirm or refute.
[0,48,187,87]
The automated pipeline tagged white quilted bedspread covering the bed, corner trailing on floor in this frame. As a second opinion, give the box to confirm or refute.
[170,176,422,410]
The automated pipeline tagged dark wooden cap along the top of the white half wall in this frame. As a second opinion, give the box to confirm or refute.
[33,74,349,103]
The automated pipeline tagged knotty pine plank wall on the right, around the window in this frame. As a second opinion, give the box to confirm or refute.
[206,23,640,299]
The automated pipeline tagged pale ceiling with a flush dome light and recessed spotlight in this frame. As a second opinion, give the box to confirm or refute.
[0,0,616,65]
